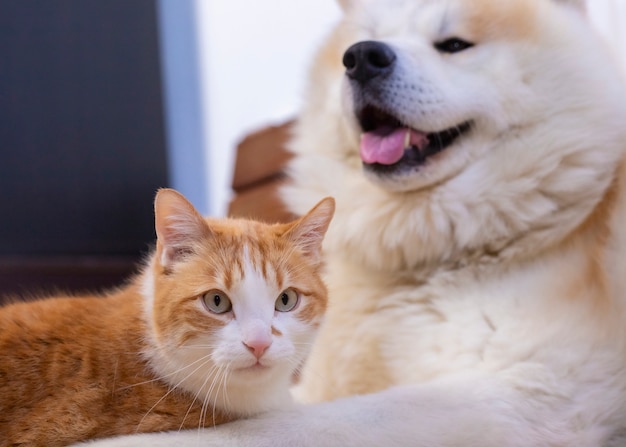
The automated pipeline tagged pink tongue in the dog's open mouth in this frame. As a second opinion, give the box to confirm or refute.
[361,127,428,165]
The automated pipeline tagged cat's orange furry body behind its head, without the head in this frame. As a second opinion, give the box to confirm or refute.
[0,288,214,446]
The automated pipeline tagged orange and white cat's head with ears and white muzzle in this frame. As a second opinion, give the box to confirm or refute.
[142,189,335,414]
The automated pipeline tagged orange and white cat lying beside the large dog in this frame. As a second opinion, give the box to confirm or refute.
[0,189,335,447]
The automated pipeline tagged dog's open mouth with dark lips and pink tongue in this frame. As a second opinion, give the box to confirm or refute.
[357,106,472,173]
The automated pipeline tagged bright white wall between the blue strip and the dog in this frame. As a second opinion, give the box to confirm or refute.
[196,0,339,215]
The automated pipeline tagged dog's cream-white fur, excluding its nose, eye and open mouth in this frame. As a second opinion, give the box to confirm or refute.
[74,0,626,447]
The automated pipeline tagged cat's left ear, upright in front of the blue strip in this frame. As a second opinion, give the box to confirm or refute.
[154,189,210,267]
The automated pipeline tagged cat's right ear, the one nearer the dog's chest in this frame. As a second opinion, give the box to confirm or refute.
[285,197,335,262]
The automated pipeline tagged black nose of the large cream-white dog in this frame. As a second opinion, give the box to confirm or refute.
[343,40,396,82]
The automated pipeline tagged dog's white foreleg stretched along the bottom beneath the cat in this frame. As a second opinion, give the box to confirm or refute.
[70,378,607,447]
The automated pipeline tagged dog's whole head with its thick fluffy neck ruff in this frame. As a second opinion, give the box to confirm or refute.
[290,0,626,270]
